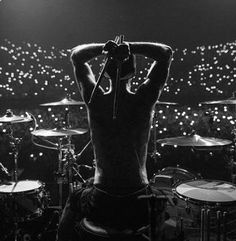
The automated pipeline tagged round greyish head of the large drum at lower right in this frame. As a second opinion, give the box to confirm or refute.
[175,179,236,204]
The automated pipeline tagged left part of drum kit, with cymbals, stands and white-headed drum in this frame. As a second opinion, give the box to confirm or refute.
[0,96,92,241]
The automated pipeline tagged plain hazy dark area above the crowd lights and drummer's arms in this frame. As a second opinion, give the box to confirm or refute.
[0,0,236,48]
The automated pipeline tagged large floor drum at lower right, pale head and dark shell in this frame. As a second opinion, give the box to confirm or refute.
[173,179,236,240]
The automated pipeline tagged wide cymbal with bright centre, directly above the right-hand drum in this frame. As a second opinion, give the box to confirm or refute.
[157,134,232,147]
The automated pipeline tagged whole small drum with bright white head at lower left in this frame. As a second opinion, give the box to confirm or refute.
[0,180,48,222]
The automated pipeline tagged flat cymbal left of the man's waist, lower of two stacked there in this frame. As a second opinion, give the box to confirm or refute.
[31,128,87,137]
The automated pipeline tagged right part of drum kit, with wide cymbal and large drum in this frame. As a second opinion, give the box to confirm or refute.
[150,96,236,241]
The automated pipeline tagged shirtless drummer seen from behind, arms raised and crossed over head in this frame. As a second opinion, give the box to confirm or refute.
[58,38,172,241]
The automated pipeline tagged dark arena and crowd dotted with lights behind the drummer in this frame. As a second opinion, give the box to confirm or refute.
[0,0,236,203]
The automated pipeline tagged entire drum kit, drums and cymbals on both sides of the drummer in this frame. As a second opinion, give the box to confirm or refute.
[0,93,236,241]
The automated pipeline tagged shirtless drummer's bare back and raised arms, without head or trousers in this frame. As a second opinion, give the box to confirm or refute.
[72,40,171,193]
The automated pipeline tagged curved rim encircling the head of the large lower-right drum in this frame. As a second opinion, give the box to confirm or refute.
[172,178,236,207]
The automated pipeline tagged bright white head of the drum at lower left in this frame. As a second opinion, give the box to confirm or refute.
[0,180,42,193]
